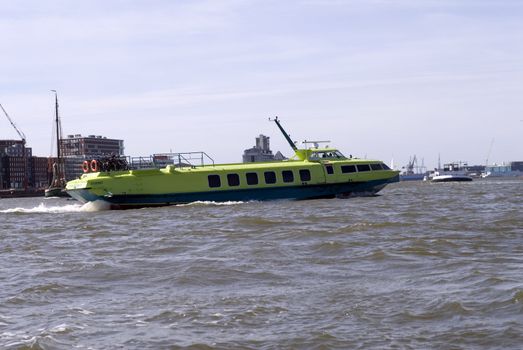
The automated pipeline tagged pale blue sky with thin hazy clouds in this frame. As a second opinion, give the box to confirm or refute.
[0,0,523,168]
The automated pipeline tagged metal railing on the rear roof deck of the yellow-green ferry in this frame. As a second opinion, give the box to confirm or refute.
[128,152,214,169]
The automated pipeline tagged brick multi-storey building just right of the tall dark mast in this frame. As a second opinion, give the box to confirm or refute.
[60,134,124,181]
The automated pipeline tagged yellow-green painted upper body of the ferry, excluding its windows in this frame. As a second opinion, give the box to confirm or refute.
[66,148,398,196]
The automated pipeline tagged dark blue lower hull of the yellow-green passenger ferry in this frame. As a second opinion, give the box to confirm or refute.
[67,176,399,209]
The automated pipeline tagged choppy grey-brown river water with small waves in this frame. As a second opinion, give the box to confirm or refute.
[0,180,523,349]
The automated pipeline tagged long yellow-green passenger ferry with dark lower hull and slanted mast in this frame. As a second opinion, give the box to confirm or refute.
[66,118,399,209]
